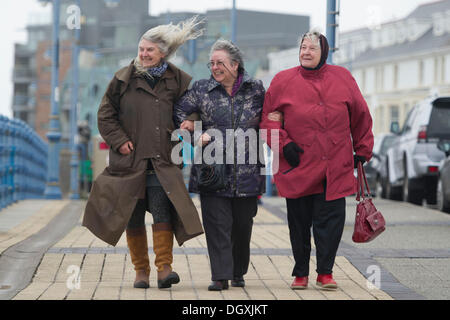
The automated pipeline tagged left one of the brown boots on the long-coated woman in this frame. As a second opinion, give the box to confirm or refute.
[126,226,150,289]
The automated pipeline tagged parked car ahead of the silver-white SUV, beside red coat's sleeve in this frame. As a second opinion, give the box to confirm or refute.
[364,133,395,198]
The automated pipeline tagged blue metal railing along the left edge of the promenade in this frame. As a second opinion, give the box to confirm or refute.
[0,115,48,210]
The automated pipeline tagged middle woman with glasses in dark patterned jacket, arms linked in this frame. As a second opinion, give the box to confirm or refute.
[175,40,265,291]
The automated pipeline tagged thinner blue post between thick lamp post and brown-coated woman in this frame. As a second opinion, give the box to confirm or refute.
[70,0,80,199]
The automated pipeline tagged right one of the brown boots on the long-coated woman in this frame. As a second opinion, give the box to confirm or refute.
[152,223,180,289]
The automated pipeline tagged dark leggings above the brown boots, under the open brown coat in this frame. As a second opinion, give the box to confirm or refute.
[127,187,174,229]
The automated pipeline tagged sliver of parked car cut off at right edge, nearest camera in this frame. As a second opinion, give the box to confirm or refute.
[436,140,450,213]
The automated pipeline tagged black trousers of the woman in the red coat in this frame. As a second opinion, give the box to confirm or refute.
[286,193,345,277]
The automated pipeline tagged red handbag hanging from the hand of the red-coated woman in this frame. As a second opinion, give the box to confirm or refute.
[352,162,386,242]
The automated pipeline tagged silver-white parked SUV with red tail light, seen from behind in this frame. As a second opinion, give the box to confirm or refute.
[385,97,450,204]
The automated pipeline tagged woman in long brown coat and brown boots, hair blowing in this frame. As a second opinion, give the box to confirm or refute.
[83,17,203,288]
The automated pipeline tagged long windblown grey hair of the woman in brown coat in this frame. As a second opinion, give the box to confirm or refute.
[134,16,205,73]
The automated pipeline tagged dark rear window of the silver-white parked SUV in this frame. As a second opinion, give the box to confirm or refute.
[427,98,450,139]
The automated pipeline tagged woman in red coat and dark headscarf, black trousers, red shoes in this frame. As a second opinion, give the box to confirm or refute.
[260,32,373,289]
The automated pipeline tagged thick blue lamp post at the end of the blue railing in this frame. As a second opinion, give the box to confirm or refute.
[39,0,62,199]
